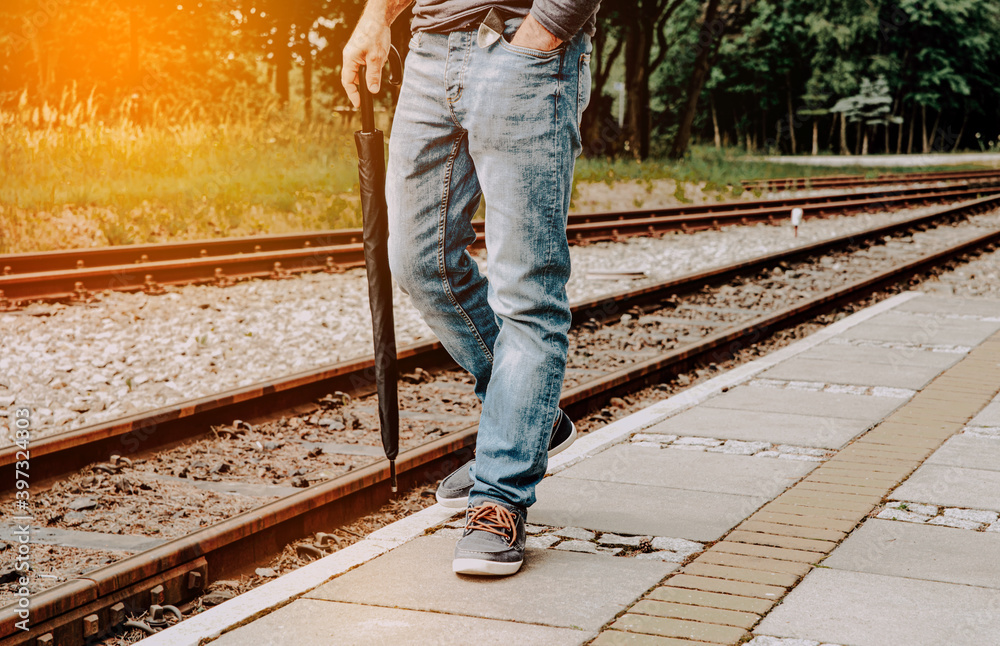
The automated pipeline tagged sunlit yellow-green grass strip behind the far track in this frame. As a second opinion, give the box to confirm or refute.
[0,101,992,253]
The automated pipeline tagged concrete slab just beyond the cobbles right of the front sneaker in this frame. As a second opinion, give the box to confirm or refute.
[528,476,768,542]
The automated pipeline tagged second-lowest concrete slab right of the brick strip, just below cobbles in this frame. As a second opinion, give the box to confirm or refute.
[823,520,1000,589]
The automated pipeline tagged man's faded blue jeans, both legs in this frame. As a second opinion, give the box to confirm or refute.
[386,18,592,510]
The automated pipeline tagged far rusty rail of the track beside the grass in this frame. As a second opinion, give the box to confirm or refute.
[0,180,1000,275]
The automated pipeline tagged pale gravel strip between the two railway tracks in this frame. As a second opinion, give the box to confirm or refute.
[0,205,992,443]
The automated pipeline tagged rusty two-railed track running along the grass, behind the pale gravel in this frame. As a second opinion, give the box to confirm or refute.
[0,180,1000,310]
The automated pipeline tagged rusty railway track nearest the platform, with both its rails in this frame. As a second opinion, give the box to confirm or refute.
[0,195,1000,644]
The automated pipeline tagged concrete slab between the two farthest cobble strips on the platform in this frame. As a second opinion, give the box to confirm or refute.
[840,312,1000,346]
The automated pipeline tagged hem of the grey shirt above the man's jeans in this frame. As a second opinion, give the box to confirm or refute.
[410,0,601,40]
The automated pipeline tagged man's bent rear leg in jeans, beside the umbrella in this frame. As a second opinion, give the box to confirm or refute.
[386,33,499,399]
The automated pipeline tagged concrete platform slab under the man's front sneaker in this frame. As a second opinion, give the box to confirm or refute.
[308,536,677,632]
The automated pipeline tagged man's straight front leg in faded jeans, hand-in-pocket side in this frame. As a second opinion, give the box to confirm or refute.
[454,20,590,518]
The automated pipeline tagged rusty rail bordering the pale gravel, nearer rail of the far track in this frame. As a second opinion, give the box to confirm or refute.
[0,186,1000,307]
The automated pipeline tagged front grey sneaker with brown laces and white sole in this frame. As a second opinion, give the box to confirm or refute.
[451,501,525,576]
